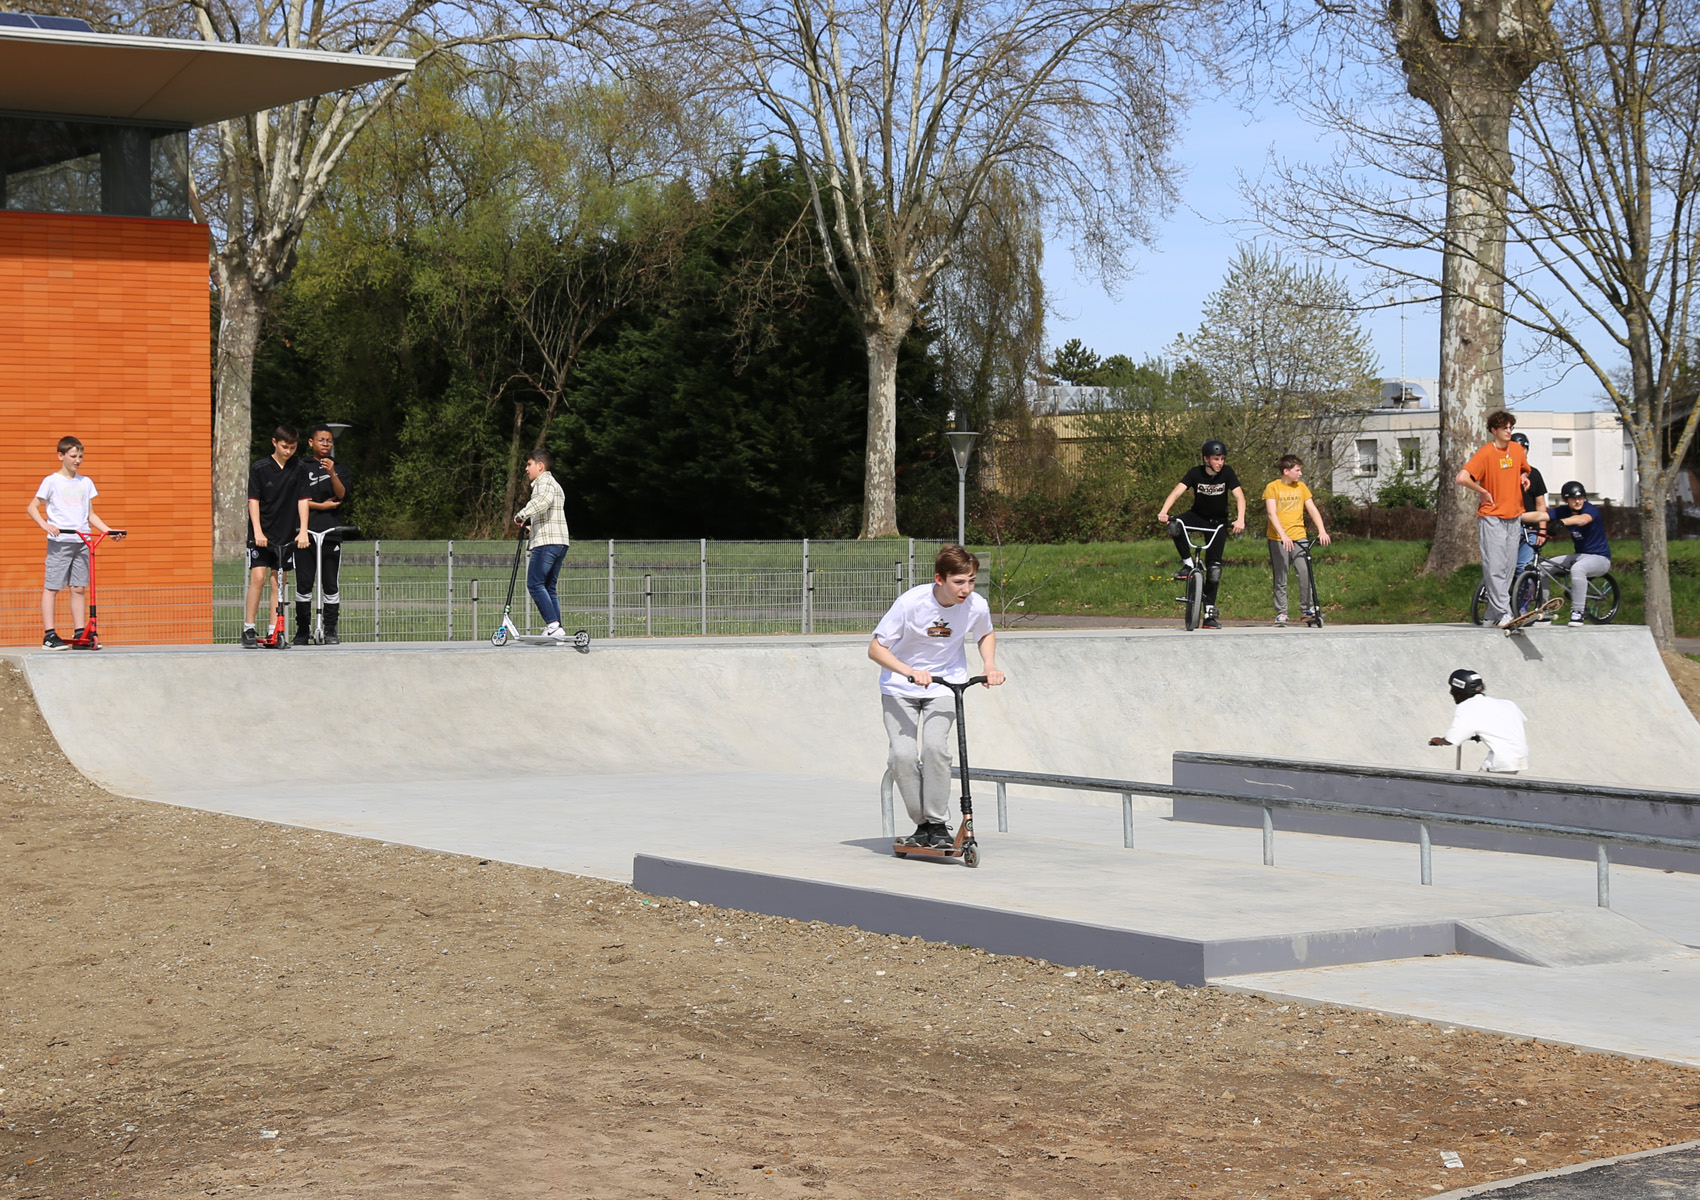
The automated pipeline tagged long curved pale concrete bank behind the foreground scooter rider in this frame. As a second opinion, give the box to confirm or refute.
[22,625,1700,799]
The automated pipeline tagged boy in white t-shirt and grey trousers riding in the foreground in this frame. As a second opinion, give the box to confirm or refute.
[867,546,1003,846]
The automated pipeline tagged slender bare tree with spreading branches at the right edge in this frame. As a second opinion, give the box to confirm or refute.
[1265,0,1700,646]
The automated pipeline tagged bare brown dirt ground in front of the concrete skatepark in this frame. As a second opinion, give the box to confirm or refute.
[0,665,1700,1200]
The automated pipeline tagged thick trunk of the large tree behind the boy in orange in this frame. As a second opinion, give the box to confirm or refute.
[1423,87,1511,576]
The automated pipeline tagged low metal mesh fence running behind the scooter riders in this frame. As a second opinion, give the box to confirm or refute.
[0,539,938,646]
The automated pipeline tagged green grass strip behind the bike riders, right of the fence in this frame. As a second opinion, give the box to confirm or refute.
[976,537,1700,637]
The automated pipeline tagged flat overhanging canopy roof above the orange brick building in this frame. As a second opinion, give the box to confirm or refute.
[0,14,413,126]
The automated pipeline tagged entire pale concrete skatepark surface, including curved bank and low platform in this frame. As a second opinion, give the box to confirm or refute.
[7,627,1700,1195]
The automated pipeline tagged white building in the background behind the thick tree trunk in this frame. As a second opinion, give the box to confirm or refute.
[1312,379,1639,505]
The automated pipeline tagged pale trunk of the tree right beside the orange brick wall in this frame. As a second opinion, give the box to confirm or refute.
[213,270,265,559]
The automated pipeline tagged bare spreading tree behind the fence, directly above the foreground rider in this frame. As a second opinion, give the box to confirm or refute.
[709,0,1183,537]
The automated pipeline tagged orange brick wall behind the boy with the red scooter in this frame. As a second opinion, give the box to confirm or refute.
[0,211,213,644]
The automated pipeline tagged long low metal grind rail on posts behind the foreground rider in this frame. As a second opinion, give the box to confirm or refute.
[879,767,1700,908]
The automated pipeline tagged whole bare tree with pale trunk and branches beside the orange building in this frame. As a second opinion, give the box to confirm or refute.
[133,0,644,554]
